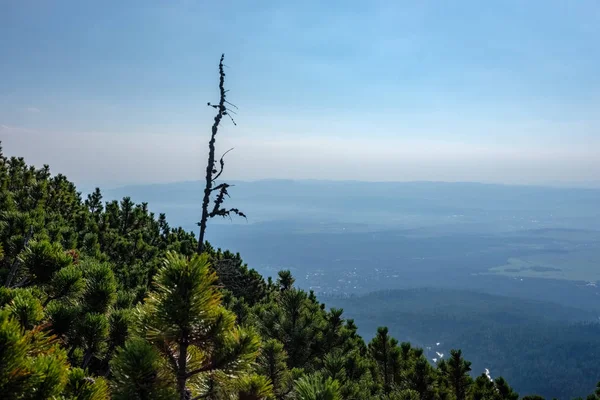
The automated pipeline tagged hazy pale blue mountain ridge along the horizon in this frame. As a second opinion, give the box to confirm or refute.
[104,180,600,230]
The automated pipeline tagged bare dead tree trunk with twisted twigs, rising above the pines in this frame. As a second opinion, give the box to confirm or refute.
[198,54,246,254]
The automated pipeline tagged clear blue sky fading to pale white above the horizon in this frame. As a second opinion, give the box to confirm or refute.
[0,0,600,187]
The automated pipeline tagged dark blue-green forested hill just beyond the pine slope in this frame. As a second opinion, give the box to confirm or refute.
[321,288,600,399]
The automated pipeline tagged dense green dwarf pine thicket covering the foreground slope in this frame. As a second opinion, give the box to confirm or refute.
[0,142,600,400]
